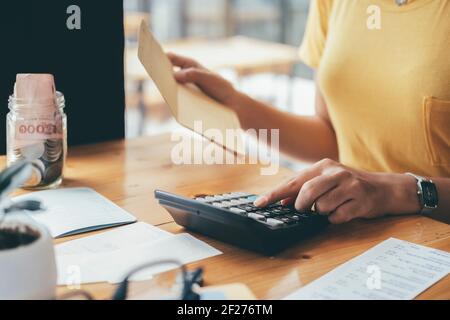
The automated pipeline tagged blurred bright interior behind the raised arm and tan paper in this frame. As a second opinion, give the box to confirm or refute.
[124,0,314,138]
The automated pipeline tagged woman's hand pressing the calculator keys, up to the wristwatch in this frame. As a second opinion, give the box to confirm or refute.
[255,160,420,224]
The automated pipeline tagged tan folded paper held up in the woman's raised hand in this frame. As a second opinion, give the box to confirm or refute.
[138,21,245,155]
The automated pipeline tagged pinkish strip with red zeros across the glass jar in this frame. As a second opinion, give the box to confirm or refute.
[15,120,63,140]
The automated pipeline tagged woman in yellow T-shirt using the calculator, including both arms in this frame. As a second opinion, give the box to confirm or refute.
[169,0,450,223]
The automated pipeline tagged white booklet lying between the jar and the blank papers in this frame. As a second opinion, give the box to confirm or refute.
[13,188,136,238]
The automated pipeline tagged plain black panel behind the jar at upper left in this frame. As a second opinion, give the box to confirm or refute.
[0,0,125,154]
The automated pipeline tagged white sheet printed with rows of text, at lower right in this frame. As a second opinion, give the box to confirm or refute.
[286,239,450,300]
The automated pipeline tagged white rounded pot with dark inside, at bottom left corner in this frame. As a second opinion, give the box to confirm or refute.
[0,215,57,300]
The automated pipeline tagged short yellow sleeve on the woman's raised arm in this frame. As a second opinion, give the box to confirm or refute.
[300,0,332,69]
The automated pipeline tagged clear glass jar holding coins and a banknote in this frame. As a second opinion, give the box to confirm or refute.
[6,92,67,190]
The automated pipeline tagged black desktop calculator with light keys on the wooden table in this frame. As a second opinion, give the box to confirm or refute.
[155,191,329,255]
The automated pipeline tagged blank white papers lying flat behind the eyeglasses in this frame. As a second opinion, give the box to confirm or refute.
[56,223,221,285]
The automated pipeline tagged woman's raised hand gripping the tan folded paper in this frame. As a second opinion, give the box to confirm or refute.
[167,53,241,109]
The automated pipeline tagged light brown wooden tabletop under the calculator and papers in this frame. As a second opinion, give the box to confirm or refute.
[2,135,450,299]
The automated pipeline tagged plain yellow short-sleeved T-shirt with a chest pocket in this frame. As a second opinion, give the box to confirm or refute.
[300,0,450,177]
